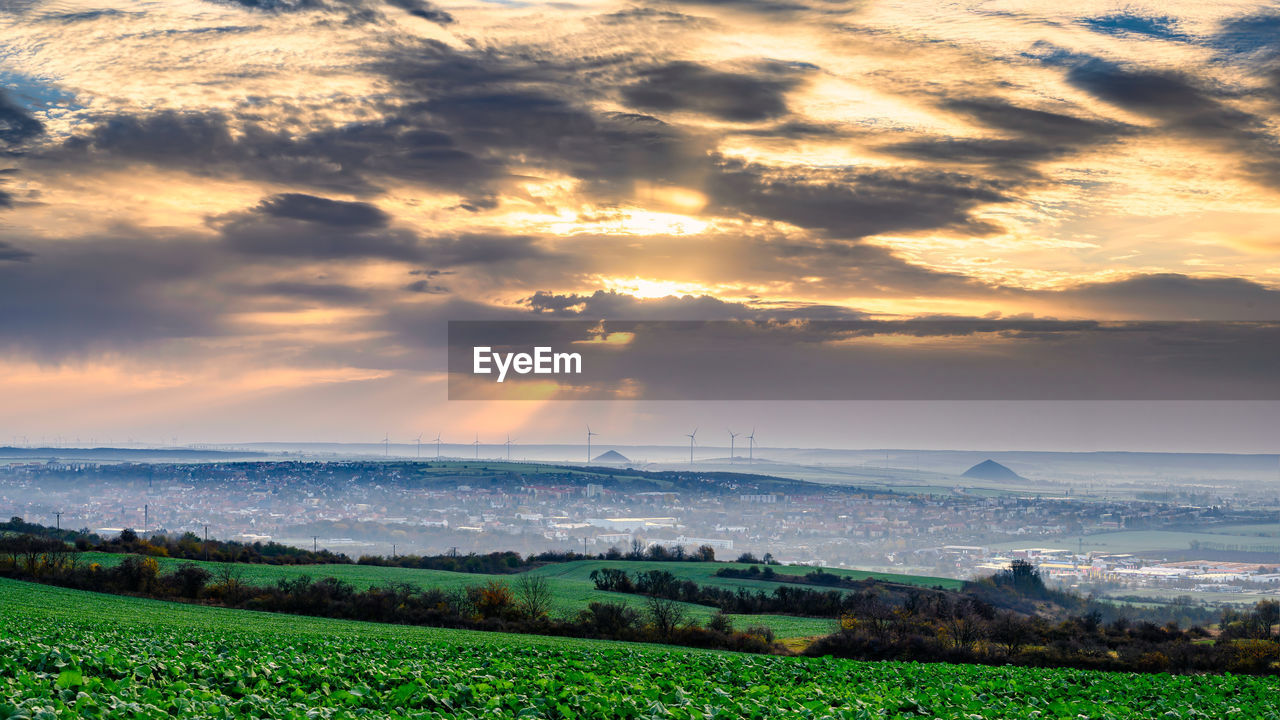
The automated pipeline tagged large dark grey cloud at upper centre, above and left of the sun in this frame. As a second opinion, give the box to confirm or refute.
[375,42,710,199]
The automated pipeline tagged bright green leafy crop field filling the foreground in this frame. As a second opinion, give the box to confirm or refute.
[0,580,1280,720]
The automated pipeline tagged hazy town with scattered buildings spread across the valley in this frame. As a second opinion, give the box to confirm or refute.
[0,460,1280,600]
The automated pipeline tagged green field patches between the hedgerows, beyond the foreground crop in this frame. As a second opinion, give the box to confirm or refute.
[82,552,836,639]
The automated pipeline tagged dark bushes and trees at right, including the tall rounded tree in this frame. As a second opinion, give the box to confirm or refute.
[591,562,1280,674]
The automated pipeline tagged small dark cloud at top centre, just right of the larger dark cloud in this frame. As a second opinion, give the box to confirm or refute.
[622,61,801,122]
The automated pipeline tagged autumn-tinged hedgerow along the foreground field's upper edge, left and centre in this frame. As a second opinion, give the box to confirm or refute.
[0,537,788,653]
